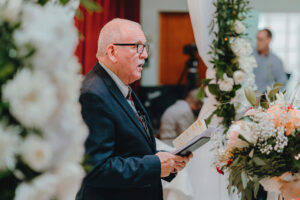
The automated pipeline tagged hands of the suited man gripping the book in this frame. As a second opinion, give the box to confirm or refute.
[156,152,193,177]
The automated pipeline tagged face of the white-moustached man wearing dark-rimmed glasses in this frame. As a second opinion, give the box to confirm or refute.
[115,27,148,84]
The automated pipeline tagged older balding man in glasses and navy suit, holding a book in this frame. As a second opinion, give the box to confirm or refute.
[76,19,192,200]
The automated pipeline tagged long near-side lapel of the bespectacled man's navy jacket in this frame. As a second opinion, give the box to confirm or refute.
[95,63,155,150]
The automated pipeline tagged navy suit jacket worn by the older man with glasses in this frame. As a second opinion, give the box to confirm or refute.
[76,63,168,200]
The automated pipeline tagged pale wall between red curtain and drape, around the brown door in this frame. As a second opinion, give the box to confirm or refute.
[141,0,188,86]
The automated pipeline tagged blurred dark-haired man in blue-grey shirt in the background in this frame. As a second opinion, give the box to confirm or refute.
[253,29,287,93]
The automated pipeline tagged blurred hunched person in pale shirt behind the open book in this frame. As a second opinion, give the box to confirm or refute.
[159,89,202,146]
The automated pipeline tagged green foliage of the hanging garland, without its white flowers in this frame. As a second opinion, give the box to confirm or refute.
[200,0,254,131]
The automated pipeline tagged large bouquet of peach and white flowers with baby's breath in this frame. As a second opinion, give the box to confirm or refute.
[217,84,300,200]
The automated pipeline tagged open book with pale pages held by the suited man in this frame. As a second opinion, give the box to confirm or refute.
[172,119,215,156]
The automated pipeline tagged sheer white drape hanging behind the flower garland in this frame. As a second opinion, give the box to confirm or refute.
[187,0,238,200]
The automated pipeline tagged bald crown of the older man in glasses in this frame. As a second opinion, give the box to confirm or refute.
[97,18,141,60]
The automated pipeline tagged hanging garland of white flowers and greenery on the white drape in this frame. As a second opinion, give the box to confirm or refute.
[199,0,257,129]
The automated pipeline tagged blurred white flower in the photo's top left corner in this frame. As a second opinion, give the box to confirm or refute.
[0,0,23,23]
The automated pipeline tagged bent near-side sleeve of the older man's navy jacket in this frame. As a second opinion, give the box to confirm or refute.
[80,93,161,188]
